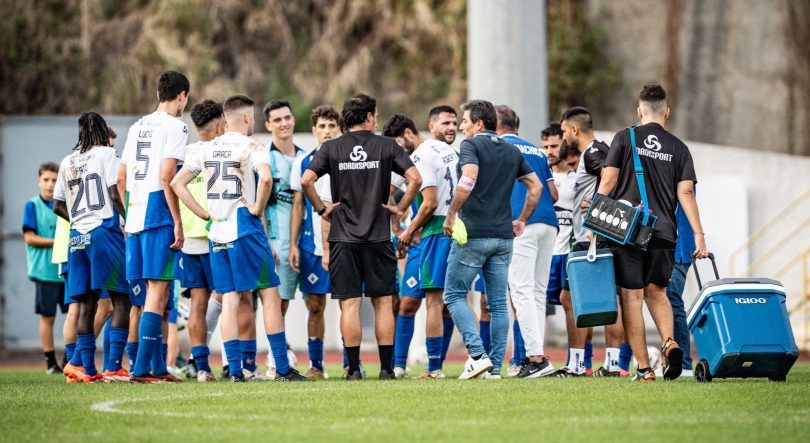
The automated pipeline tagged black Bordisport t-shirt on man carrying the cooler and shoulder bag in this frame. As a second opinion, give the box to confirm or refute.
[605,123,697,242]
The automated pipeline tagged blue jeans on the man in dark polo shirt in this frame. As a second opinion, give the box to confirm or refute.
[444,238,512,371]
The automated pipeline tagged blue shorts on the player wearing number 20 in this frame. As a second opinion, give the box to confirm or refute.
[65,226,129,300]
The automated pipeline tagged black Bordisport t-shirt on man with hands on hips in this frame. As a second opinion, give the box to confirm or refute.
[307,131,413,243]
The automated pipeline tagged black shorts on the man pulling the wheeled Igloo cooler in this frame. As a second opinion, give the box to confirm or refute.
[610,237,675,289]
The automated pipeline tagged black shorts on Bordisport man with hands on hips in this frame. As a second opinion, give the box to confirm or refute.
[329,241,397,299]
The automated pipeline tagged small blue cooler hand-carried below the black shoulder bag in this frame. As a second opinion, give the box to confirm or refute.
[566,241,619,328]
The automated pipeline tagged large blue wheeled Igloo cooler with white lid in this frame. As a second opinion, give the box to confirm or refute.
[686,254,799,382]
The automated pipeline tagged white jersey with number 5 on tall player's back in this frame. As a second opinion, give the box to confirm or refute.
[121,112,188,233]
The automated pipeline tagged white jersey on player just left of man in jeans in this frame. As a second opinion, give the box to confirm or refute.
[411,140,458,237]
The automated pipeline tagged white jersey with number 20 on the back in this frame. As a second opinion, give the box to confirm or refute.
[53,146,118,234]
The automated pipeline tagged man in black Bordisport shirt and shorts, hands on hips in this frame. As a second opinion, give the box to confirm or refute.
[301,94,422,380]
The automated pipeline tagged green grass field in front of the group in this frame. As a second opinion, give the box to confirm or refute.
[0,363,810,443]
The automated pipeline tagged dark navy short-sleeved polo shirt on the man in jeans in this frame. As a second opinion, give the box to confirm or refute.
[458,131,534,238]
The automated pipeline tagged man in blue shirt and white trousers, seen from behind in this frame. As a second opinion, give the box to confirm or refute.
[497,105,559,378]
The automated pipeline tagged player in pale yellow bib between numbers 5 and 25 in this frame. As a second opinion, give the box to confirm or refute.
[180,99,225,382]
